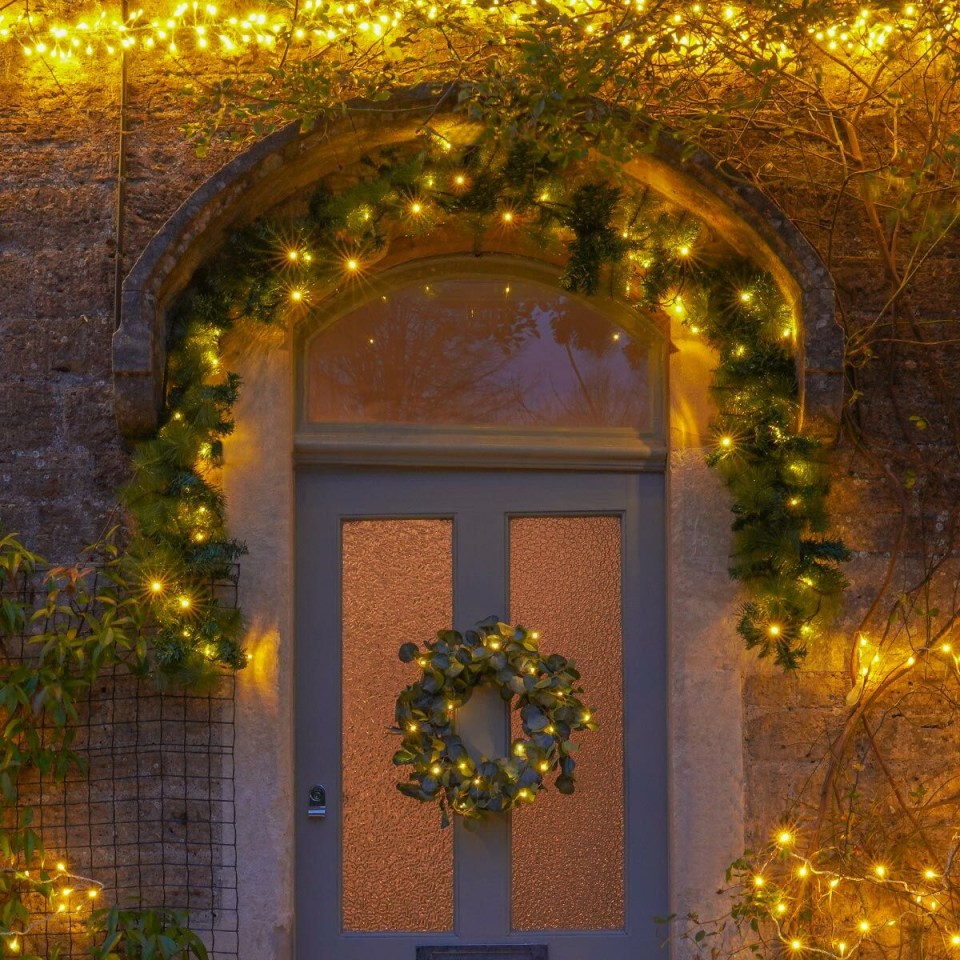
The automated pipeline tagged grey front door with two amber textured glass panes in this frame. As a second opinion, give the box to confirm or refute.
[296,465,667,960]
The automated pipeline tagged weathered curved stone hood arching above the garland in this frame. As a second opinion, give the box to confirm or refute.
[113,91,843,438]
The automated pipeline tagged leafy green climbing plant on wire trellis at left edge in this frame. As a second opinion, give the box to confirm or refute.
[0,534,165,956]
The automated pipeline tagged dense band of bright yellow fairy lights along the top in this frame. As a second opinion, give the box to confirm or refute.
[0,0,960,76]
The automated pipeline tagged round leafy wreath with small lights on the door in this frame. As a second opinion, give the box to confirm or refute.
[393,617,596,827]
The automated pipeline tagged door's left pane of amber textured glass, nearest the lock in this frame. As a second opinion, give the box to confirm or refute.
[342,520,453,930]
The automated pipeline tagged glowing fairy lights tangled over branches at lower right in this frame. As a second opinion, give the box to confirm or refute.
[680,628,960,960]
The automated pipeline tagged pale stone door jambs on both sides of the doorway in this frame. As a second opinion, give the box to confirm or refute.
[216,246,752,960]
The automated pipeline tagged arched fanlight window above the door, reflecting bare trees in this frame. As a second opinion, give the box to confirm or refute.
[307,277,650,430]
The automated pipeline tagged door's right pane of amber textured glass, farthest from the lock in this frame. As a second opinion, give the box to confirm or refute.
[510,517,624,930]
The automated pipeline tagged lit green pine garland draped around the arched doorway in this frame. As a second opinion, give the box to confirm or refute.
[124,139,846,675]
